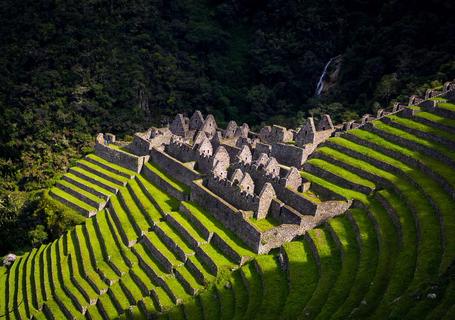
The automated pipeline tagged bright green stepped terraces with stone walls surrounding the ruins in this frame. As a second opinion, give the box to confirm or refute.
[0,84,455,319]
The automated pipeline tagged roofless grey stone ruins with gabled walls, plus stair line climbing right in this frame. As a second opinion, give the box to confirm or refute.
[95,82,455,253]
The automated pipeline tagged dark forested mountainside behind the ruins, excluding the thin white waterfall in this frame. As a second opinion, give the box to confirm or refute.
[0,0,455,254]
